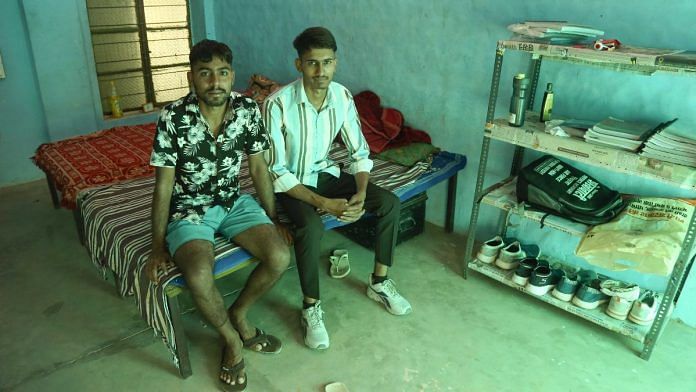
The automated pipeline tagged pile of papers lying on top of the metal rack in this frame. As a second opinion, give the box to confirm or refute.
[508,21,604,45]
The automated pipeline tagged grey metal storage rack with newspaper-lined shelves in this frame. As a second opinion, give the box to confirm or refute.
[463,40,696,360]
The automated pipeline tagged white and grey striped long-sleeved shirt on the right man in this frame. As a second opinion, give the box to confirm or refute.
[263,78,372,192]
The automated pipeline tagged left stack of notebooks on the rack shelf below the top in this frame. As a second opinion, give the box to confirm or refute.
[584,117,655,151]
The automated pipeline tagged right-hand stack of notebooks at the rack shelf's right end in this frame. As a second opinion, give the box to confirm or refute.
[640,123,696,167]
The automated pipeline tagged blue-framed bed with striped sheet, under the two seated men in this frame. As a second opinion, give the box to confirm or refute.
[78,144,466,377]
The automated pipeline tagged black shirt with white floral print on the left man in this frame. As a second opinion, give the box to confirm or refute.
[150,92,270,223]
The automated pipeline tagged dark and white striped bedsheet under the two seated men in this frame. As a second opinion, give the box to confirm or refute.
[79,144,430,365]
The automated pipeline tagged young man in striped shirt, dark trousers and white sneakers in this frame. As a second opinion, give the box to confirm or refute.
[264,27,411,349]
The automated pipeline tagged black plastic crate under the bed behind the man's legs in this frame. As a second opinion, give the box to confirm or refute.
[336,192,428,249]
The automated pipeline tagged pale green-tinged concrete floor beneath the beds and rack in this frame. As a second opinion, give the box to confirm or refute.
[0,181,696,392]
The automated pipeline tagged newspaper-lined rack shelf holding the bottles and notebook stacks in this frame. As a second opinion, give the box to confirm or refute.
[484,112,696,190]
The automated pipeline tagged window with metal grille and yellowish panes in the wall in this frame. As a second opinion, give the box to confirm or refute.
[86,0,191,115]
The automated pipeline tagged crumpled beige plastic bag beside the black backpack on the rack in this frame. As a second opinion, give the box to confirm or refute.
[576,197,696,276]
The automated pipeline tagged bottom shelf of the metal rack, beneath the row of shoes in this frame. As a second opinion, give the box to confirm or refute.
[469,259,650,343]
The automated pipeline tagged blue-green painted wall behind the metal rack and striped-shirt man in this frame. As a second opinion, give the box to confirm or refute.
[215,0,696,326]
